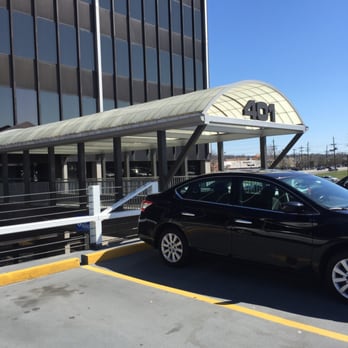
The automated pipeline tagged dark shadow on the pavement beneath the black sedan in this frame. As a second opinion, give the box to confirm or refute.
[98,249,348,322]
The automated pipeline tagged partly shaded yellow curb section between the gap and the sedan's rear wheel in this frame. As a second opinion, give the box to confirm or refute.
[81,242,149,265]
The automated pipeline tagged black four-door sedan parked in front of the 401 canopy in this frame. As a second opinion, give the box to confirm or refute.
[138,171,348,300]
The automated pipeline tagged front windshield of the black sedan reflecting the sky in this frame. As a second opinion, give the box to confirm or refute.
[278,174,348,210]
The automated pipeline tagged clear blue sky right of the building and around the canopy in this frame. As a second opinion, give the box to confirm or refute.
[207,0,348,155]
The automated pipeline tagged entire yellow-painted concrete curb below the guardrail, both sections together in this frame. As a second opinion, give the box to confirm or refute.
[0,239,148,286]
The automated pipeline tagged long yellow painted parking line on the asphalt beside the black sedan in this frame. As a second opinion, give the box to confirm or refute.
[82,265,348,342]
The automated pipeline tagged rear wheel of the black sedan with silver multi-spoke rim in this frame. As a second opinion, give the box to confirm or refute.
[159,228,190,266]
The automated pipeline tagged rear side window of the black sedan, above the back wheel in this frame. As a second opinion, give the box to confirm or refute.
[176,178,232,204]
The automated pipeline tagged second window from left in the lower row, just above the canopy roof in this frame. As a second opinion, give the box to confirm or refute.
[16,88,38,125]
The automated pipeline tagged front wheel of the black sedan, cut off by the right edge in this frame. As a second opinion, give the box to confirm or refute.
[325,252,348,301]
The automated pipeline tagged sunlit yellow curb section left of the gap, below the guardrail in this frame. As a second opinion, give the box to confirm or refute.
[0,258,80,286]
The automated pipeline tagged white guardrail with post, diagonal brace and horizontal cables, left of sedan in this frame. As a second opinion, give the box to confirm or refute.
[0,182,158,266]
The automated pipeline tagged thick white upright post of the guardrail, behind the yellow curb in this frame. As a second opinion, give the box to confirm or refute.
[88,185,103,247]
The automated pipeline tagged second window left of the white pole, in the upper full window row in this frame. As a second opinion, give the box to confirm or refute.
[59,24,77,67]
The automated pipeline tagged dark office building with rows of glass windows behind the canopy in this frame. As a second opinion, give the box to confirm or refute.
[0,0,208,184]
